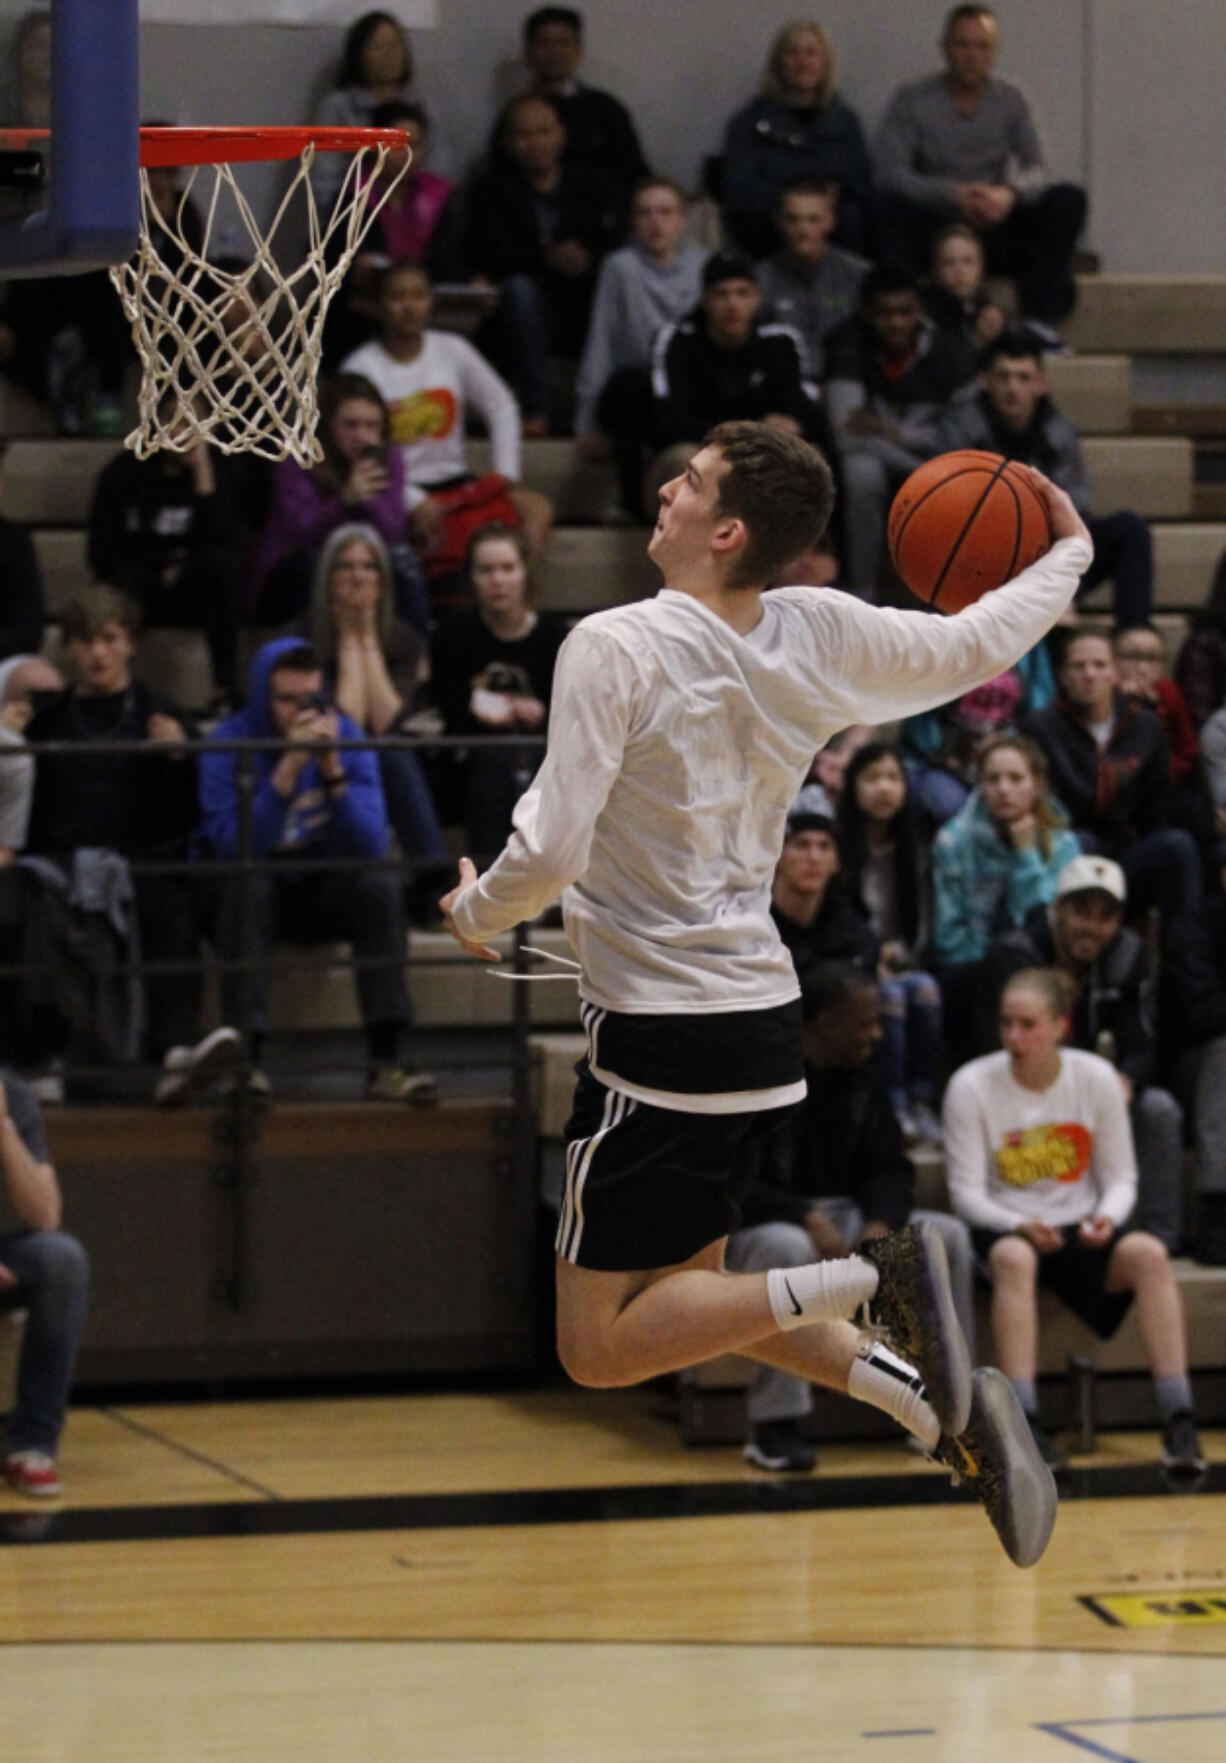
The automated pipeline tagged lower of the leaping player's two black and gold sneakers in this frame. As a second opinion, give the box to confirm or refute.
[935,1366,1058,1567]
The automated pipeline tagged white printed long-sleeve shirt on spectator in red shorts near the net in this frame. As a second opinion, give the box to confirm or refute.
[340,331,522,508]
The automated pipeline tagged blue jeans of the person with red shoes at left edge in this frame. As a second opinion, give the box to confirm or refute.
[0,1231,90,1456]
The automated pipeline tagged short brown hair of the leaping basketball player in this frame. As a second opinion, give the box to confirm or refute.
[702,423,834,587]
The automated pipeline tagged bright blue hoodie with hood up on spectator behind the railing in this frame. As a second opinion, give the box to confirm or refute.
[199,636,388,857]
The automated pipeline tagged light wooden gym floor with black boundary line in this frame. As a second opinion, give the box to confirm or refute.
[0,1387,1226,1763]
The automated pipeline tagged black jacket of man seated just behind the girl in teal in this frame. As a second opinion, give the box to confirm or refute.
[1025,693,1171,857]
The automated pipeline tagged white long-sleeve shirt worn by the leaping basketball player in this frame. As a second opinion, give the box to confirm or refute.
[453,539,1092,1014]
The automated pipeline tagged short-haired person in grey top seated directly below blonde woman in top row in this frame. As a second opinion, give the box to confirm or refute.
[759,178,868,379]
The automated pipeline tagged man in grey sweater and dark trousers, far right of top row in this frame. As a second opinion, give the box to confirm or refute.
[873,5,1085,324]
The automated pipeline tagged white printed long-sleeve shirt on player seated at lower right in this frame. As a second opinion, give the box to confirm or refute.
[940,1047,1136,1231]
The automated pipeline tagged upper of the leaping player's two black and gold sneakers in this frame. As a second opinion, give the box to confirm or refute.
[857,1222,970,1439]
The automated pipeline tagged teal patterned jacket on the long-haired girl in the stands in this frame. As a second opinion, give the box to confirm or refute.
[933,790,1081,966]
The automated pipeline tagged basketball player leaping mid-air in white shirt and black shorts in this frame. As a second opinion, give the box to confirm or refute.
[441,423,1092,1566]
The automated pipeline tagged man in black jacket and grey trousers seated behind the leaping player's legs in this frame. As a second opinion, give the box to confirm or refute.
[727,963,974,1472]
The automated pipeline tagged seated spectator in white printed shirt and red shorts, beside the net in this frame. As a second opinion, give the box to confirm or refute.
[344,263,554,608]
